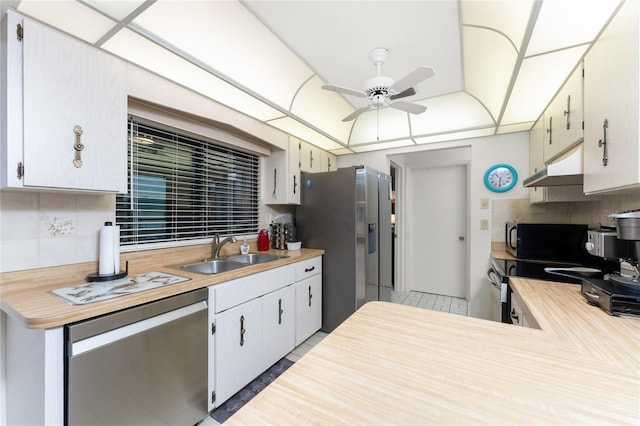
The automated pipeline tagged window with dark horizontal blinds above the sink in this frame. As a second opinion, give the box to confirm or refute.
[116,119,260,246]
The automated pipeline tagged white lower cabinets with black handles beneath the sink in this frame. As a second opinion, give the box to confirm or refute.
[208,257,322,410]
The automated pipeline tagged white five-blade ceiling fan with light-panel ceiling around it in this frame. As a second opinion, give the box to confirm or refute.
[322,47,434,121]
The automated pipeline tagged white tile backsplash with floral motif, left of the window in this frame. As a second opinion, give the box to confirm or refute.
[0,191,115,272]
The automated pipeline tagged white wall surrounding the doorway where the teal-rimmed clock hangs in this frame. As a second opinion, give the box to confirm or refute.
[337,132,529,319]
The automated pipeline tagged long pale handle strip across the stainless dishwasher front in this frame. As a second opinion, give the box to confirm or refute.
[69,300,207,357]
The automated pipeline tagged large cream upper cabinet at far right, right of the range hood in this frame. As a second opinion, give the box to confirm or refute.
[584,1,640,193]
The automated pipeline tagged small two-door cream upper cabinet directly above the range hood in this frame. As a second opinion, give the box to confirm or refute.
[544,66,583,162]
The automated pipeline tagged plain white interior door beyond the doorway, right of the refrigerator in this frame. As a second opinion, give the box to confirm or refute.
[404,166,467,298]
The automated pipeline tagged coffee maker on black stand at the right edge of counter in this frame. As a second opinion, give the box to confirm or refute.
[581,210,640,316]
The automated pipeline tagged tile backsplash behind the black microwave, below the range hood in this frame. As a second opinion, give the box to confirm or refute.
[491,194,640,241]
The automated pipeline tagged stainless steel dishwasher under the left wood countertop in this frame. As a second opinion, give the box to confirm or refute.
[65,289,208,425]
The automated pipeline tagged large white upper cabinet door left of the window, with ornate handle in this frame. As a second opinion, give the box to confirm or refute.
[22,19,127,192]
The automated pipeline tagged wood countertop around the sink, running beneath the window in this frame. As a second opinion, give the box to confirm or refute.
[0,243,324,329]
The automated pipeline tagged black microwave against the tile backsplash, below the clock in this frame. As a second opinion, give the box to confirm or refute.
[505,222,588,262]
